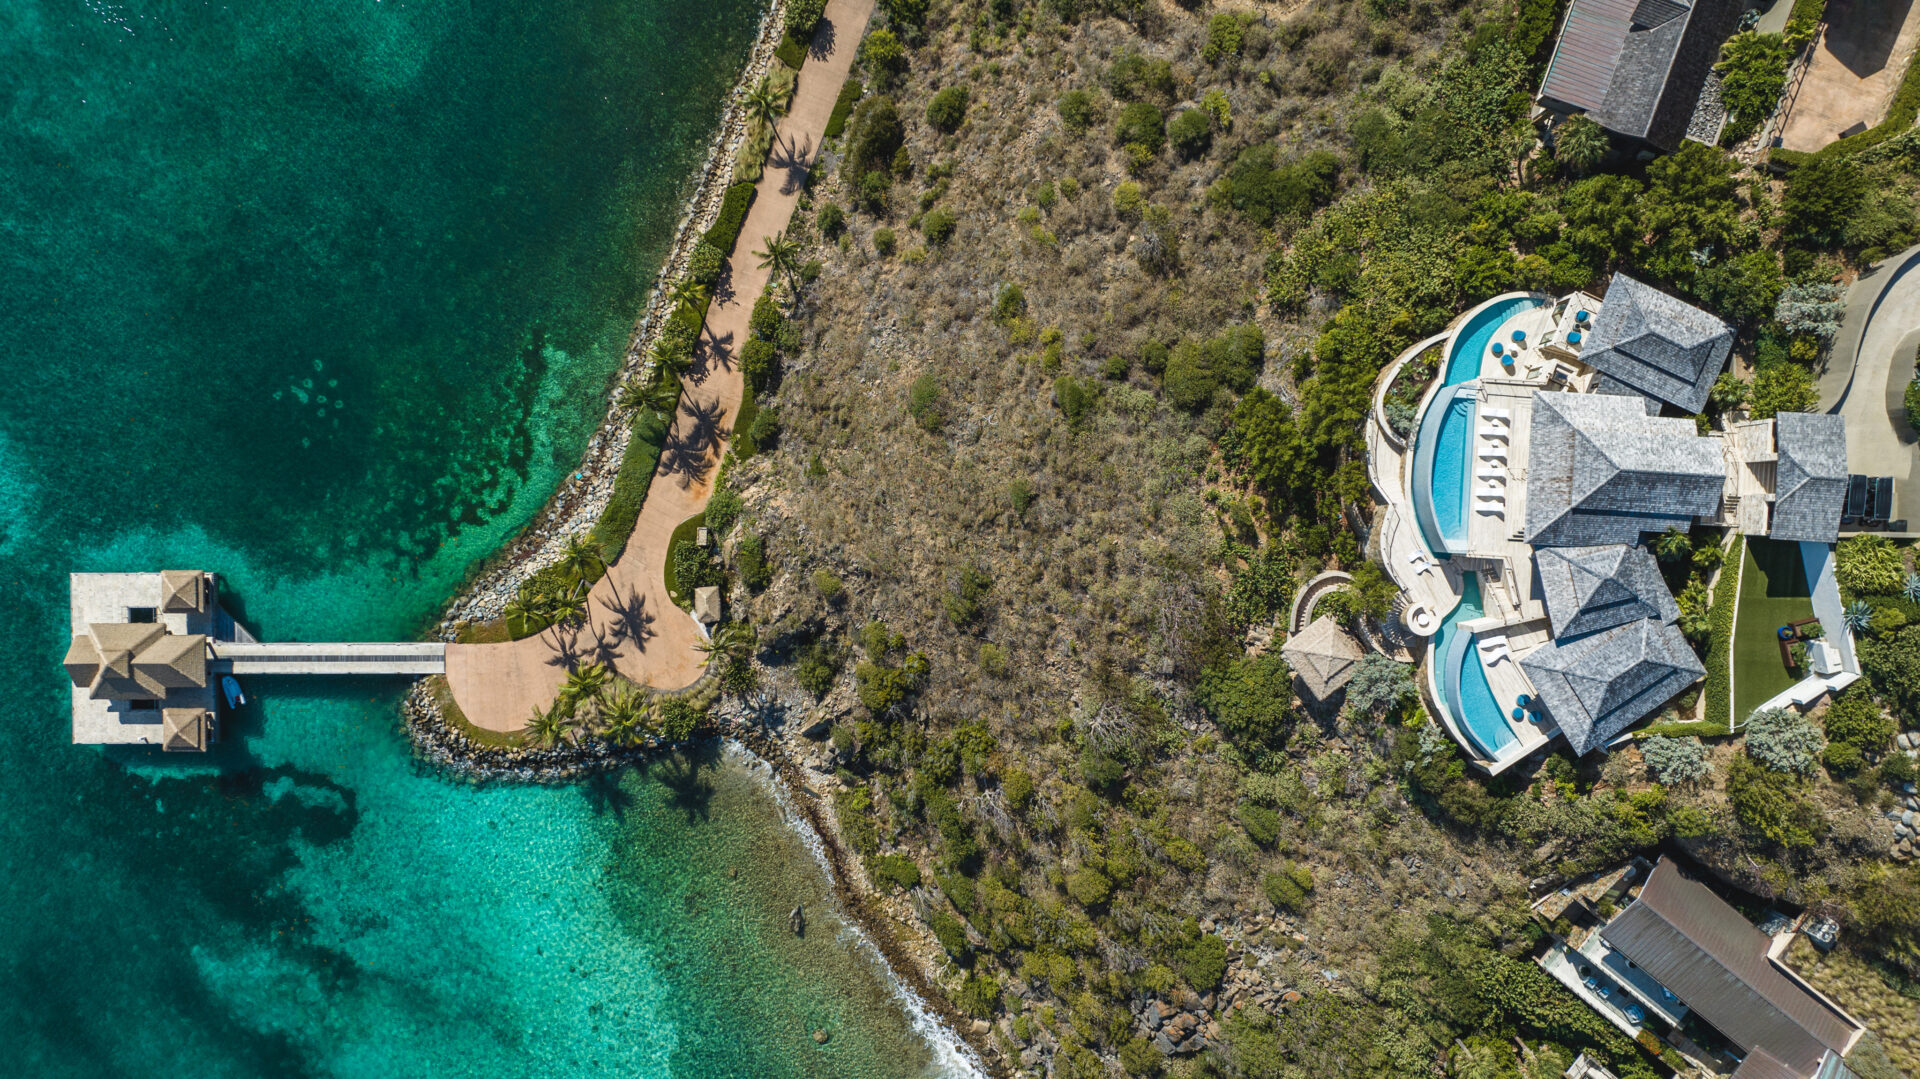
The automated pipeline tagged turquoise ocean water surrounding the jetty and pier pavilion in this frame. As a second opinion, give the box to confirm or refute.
[0,0,960,1079]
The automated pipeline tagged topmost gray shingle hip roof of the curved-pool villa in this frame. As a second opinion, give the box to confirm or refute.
[1580,273,1734,413]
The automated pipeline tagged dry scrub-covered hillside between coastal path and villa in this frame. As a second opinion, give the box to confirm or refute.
[683,0,1920,1079]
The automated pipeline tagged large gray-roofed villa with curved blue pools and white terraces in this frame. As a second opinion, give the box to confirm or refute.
[1367,276,1859,774]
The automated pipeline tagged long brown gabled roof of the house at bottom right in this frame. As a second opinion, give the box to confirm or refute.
[1599,858,1860,1079]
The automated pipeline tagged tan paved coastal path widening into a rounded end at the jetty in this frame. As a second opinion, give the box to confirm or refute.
[447,0,874,731]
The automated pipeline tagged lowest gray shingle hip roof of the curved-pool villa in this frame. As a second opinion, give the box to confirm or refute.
[1521,618,1707,756]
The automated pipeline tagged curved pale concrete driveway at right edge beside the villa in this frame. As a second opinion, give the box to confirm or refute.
[1820,246,1920,530]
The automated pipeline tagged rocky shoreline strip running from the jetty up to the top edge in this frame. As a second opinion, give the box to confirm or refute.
[428,0,787,629]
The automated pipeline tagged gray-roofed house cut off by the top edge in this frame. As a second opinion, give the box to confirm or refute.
[1536,0,1743,150]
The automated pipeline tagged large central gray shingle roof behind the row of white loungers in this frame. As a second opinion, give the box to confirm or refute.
[1524,390,1726,547]
